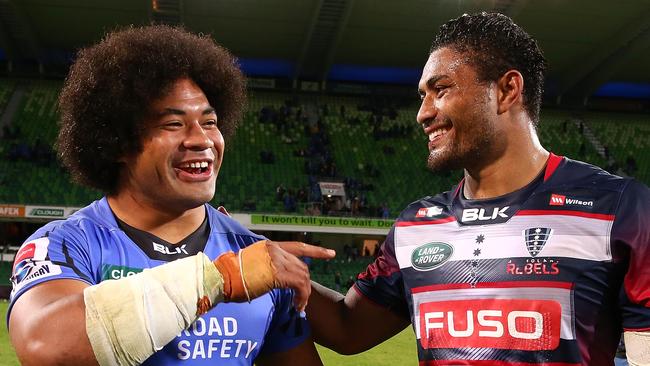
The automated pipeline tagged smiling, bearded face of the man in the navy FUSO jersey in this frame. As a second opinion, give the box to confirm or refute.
[417,47,505,171]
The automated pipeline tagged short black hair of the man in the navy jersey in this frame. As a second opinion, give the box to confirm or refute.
[431,12,546,124]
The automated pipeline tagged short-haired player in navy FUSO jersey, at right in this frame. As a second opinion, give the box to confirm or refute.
[307,13,650,366]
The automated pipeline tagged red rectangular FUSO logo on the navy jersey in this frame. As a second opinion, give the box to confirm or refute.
[419,299,562,351]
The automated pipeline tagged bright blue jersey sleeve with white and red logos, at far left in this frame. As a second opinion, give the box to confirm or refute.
[7,221,95,320]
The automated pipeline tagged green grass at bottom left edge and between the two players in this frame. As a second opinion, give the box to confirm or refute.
[0,300,418,366]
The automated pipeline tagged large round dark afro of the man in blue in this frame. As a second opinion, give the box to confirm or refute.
[56,25,246,194]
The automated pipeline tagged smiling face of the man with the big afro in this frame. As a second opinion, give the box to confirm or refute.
[118,79,224,212]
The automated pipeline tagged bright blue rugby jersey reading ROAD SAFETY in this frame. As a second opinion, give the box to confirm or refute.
[7,198,309,365]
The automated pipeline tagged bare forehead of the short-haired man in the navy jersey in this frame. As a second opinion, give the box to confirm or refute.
[419,47,476,88]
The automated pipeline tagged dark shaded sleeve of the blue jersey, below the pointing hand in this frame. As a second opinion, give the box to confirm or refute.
[261,289,311,354]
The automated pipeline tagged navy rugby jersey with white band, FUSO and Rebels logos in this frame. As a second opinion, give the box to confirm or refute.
[355,154,650,366]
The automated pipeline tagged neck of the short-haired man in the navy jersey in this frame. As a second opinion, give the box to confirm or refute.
[463,124,549,199]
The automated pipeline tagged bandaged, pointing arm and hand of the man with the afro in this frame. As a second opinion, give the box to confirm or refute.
[9,241,334,365]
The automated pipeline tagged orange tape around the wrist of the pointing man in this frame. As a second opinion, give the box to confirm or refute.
[214,240,279,302]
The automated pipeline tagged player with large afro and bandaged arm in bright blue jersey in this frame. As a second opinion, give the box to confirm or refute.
[7,25,334,365]
